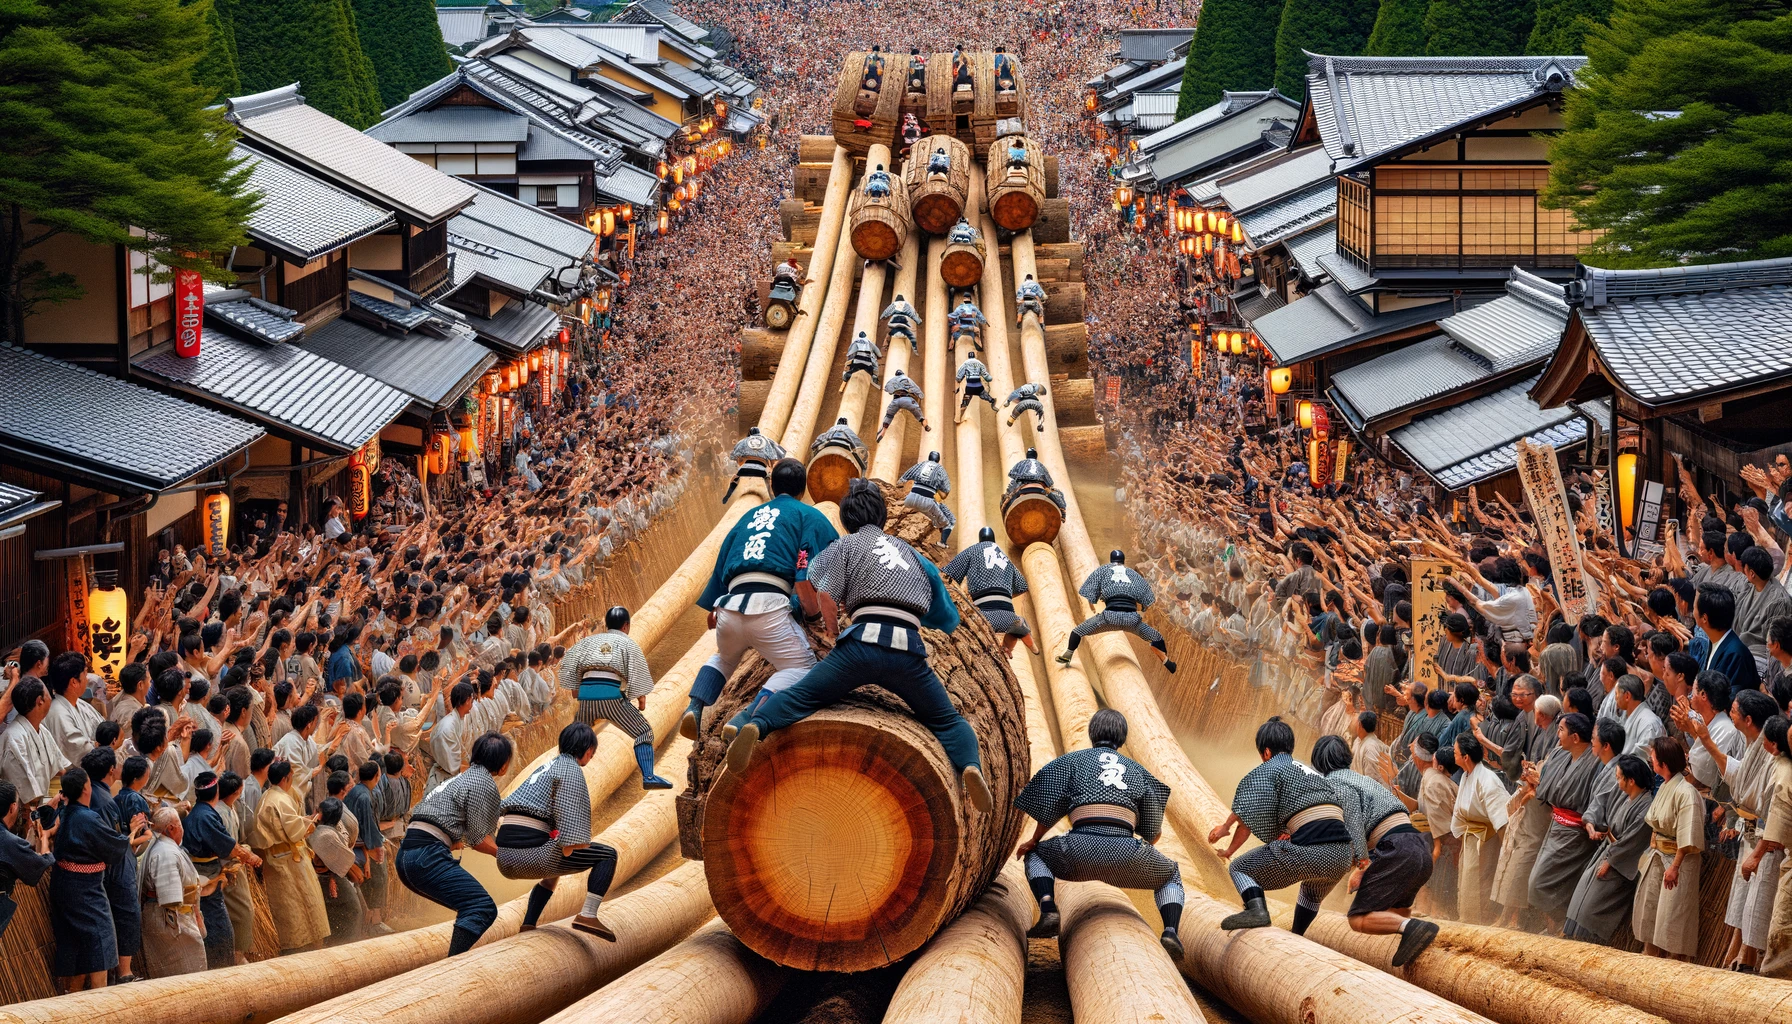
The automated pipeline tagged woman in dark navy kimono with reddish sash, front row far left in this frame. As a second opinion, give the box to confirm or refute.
[50,768,131,992]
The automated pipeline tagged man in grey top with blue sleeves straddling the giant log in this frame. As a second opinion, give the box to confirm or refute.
[722,477,995,812]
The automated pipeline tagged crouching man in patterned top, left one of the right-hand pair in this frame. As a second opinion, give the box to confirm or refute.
[1208,717,1369,934]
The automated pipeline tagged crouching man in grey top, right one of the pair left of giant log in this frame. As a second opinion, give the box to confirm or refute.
[495,721,616,942]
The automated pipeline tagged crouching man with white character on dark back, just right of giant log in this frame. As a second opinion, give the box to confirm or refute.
[1014,708,1183,959]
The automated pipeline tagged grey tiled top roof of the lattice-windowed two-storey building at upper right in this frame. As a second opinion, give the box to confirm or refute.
[1306,54,1586,172]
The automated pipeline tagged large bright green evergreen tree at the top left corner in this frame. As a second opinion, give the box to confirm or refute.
[0,0,254,343]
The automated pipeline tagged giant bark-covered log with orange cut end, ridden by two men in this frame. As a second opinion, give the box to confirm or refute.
[679,509,1030,970]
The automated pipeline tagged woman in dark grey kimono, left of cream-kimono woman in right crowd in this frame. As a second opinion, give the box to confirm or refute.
[1563,753,1656,943]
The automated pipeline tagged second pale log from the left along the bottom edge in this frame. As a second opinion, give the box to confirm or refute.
[265,864,713,1024]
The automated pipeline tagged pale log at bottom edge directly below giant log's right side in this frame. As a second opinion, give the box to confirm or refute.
[883,861,1032,1024]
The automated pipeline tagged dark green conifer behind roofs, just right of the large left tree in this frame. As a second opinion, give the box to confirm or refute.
[233,0,385,127]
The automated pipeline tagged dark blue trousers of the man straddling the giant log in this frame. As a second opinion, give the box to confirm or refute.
[751,637,982,771]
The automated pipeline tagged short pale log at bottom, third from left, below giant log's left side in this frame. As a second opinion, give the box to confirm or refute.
[543,920,790,1024]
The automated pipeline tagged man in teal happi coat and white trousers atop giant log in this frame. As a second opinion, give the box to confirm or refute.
[691,459,840,739]
